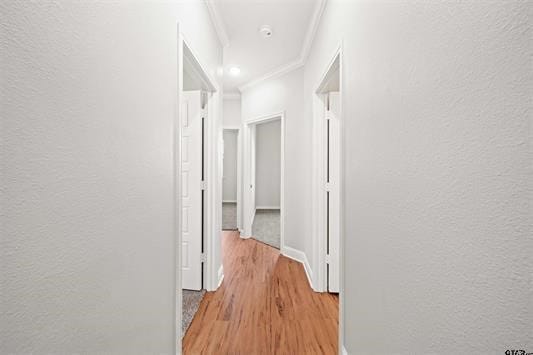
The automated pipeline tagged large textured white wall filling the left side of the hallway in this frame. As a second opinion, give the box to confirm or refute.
[0,1,222,354]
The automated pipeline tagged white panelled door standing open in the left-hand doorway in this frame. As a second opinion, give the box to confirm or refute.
[181,91,205,290]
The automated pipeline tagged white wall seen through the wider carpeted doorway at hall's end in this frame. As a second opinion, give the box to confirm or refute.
[255,119,281,208]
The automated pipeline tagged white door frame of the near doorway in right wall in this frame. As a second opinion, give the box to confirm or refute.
[312,41,346,351]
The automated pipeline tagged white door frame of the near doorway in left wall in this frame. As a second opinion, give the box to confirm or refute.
[172,22,223,354]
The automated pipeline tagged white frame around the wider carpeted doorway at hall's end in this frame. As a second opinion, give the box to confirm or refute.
[241,111,285,251]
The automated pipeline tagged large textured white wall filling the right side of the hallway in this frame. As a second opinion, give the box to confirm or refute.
[306,1,533,354]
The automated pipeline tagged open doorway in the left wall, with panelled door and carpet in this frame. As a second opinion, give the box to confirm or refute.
[174,30,220,345]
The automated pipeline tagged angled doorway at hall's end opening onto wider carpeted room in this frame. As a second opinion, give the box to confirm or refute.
[243,113,285,250]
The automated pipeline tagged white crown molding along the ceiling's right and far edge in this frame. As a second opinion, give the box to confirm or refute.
[238,0,327,92]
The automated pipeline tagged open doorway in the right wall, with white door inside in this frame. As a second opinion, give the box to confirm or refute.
[314,49,343,293]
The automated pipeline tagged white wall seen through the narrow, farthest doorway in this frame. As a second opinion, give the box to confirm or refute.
[222,129,238,202]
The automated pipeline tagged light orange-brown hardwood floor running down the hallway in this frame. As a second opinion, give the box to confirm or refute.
[183,232,338,355]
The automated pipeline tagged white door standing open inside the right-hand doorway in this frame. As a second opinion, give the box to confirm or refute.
[326,92,341,292]
